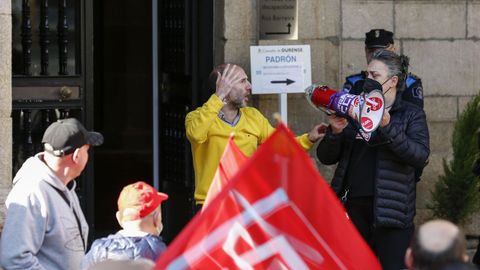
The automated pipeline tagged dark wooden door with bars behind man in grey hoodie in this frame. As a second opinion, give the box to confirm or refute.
[12,0,93,242]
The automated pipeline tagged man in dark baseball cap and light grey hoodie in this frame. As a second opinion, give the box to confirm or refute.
[0,118,103,270]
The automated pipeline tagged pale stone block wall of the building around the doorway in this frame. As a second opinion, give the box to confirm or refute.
[0,0,480,247]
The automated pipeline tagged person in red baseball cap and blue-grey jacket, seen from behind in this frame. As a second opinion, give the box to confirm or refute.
[82,181,168,269]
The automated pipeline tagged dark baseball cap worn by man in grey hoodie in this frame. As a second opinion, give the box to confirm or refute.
[42,118,103,157]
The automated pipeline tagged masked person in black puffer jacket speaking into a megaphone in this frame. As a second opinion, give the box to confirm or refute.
[317,50,430,270]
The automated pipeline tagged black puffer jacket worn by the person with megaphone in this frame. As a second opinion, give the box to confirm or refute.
[317,93,430,228]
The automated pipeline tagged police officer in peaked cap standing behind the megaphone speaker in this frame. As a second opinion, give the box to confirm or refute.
[343,29,423,109]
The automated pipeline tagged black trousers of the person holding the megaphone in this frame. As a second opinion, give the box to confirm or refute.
[345,197,414,270]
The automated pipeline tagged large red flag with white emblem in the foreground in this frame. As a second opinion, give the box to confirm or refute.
[155,125,381,270]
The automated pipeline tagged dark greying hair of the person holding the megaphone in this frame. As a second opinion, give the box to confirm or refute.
[371,50,409,92]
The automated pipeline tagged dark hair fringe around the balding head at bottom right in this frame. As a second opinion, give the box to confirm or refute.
[410,225,466,270]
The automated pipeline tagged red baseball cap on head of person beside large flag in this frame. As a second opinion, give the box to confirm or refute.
[117,181,168,221]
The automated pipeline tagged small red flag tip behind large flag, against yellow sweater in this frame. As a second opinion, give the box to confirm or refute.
[202,135,248,211]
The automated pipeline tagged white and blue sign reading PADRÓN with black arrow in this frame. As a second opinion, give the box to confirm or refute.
[250,45,312,94]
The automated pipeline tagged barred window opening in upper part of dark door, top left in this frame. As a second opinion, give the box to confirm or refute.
[12,0,80,76]
